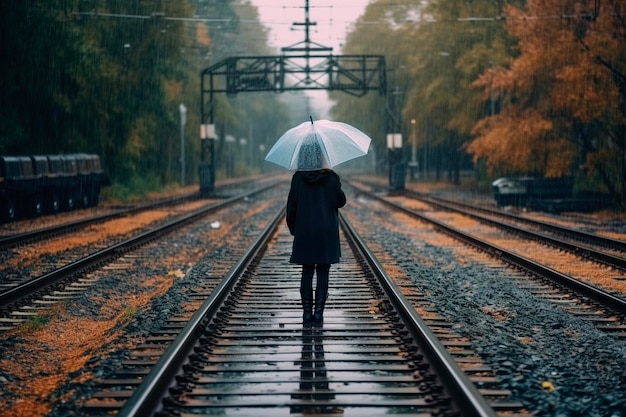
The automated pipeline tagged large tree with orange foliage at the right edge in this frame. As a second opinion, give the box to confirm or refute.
[466,0,626,204]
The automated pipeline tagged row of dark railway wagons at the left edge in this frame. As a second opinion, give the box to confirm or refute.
[0,153,109,222]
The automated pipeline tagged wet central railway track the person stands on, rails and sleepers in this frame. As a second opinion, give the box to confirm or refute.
[85,211,504,417]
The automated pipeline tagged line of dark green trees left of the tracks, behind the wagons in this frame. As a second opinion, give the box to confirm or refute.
[0,0,285,197]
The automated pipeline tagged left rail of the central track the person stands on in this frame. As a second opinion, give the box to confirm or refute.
[118,208,285,417]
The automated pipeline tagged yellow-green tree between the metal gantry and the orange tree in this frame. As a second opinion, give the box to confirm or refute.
[405,0,510,183]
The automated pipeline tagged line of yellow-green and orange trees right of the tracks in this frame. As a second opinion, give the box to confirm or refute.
[333,0,626,206]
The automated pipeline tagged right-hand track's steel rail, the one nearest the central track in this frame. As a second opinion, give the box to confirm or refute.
[354,190,626,314]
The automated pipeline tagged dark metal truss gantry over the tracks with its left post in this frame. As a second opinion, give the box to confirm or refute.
[199,0,387,193]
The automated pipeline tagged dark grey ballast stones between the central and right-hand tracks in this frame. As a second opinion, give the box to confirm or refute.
[352,203,626,417]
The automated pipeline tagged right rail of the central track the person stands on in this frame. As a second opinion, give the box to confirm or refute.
[340,211,497,417]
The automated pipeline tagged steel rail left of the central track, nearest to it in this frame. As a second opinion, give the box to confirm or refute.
[0,182,279,325]
